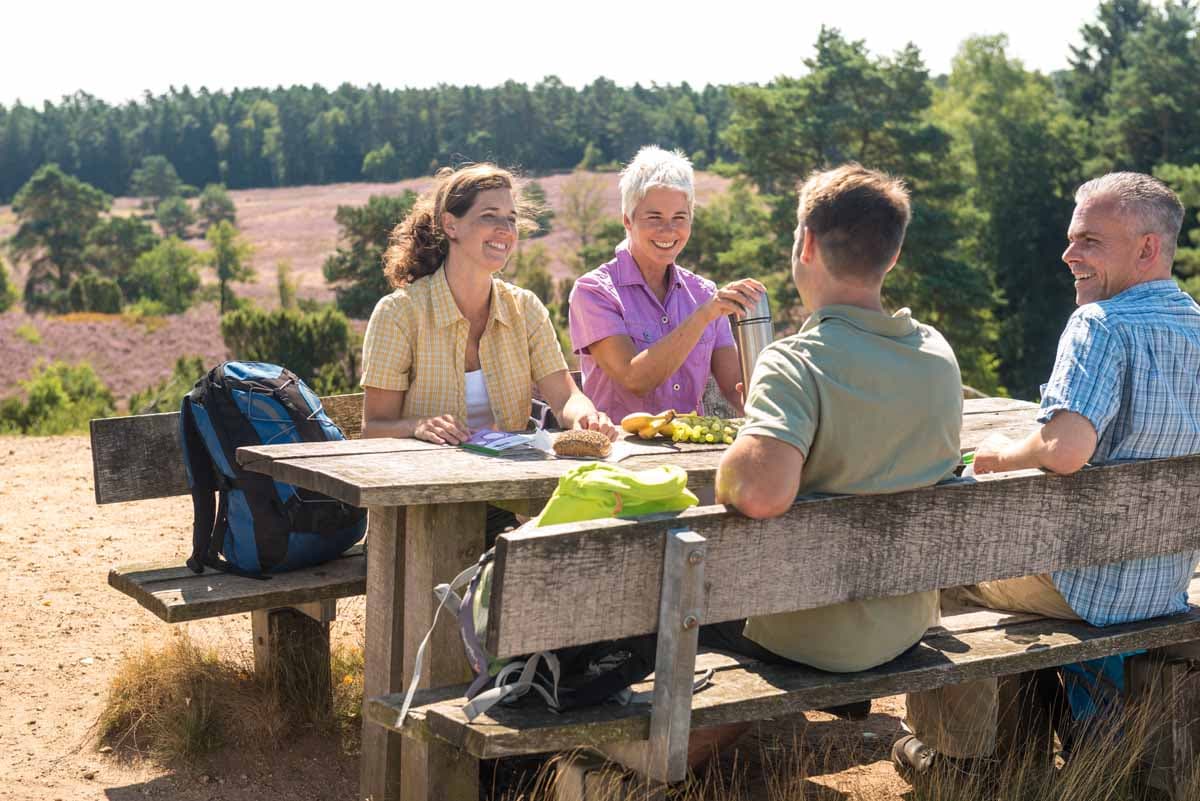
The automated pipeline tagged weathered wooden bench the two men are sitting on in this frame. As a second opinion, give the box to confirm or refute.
[364,457,1200,799]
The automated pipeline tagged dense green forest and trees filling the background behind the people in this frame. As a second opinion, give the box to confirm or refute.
[7,0,1200,397]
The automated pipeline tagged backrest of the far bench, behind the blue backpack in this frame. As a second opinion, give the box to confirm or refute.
[91,392,362,504]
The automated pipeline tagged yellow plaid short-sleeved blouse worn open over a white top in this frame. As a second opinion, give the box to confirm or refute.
[361,269,566,430]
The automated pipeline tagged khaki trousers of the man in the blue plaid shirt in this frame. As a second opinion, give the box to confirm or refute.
[905,573,1080,757]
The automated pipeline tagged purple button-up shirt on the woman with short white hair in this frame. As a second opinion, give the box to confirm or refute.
[570,247,733,421]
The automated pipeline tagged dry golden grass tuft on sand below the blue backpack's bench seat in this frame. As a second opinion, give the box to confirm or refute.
[97,630,362,764]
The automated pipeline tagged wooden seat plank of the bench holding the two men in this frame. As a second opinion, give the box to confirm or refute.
[364,608,1200,759]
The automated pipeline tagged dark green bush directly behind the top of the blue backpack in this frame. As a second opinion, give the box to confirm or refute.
[221,307,358,395]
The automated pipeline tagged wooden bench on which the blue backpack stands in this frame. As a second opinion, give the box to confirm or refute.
[91,395,366,704]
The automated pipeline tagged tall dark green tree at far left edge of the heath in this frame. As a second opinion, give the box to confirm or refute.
[8,164,112,312]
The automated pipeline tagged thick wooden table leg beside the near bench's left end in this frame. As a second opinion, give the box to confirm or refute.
[362,502,486,801]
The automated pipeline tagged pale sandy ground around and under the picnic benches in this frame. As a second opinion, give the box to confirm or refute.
[0,436,907,801]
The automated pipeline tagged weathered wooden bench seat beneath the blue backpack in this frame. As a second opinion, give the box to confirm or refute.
[108,546,367,624]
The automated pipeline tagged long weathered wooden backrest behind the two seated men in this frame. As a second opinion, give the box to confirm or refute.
[487,456,1200,657]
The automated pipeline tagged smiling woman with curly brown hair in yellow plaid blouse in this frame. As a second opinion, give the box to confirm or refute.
[362,164,617,445]
